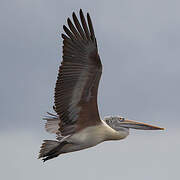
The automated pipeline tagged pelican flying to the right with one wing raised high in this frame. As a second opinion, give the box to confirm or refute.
[39,9,164,162]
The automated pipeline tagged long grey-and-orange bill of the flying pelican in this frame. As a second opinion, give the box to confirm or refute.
[119,119,164,130]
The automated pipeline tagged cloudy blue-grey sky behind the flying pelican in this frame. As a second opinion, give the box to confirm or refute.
[0,0,180,180]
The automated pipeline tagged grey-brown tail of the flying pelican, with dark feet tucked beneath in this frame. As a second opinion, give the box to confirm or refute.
[38,140,67,162]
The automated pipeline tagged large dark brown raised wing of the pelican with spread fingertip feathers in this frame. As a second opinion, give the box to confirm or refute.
[55,10,102,136]
